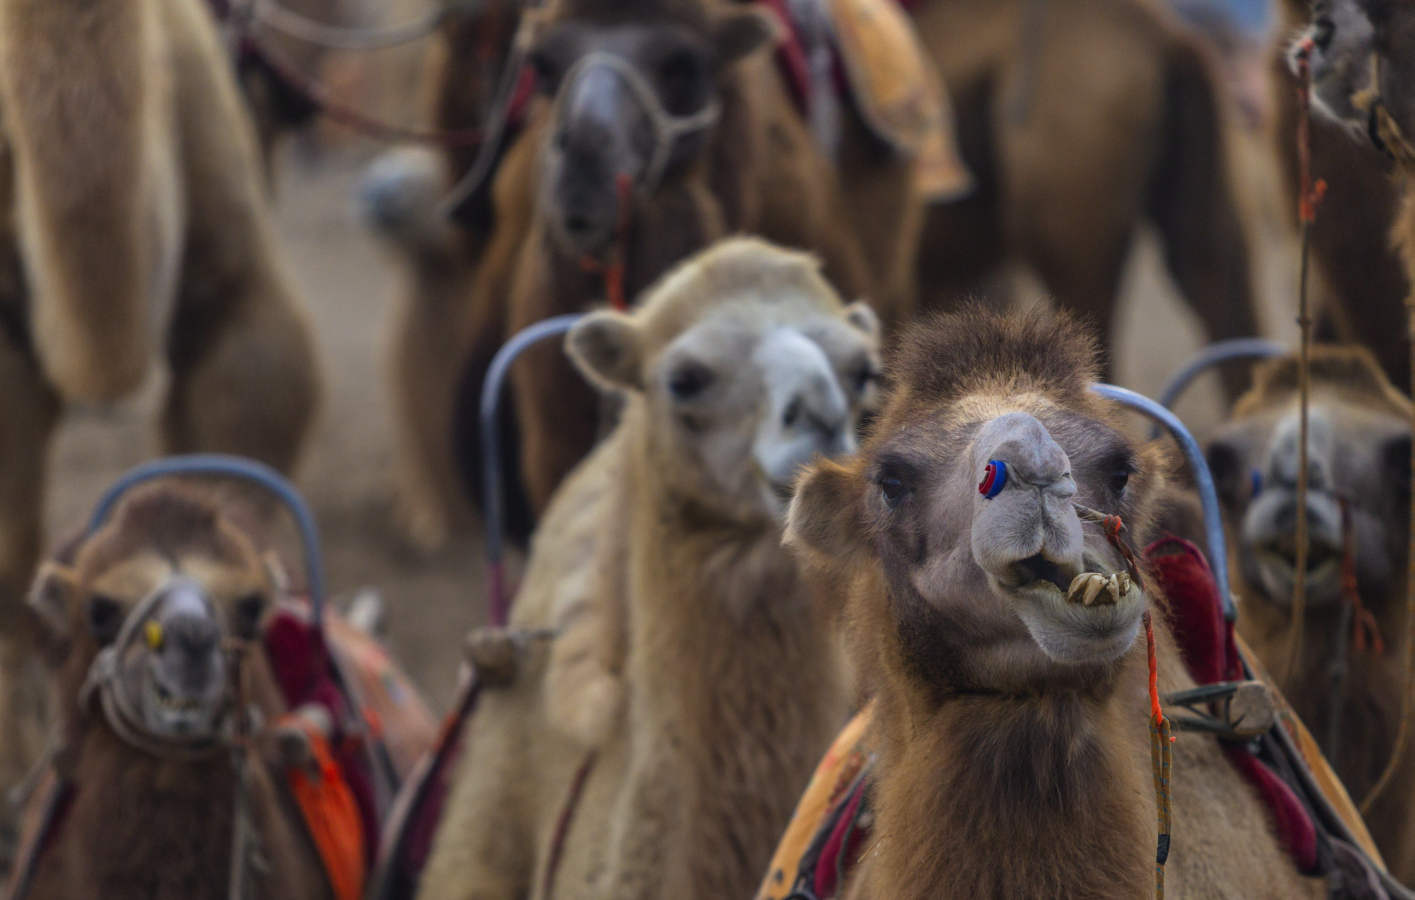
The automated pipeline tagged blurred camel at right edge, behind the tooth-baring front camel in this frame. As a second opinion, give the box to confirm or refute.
[1208,347,1415,884]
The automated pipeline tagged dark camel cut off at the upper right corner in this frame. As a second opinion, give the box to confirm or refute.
[1274,0,1411,385]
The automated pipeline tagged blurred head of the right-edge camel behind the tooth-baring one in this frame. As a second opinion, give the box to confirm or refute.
[1208,347,1411,607]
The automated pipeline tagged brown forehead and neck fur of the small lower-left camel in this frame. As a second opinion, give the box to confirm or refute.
[20,485,331,900]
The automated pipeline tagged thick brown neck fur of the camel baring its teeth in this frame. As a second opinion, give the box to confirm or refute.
[862,591,1167,900]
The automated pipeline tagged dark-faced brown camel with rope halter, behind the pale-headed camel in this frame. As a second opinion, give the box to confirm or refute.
[373,0,921,549]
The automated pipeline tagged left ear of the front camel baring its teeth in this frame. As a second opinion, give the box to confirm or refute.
[785,460,865,566]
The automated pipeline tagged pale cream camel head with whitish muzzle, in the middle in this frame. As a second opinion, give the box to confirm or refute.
[567,239,879,521]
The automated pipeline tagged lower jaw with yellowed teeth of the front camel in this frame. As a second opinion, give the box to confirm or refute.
[995,566,1148,665]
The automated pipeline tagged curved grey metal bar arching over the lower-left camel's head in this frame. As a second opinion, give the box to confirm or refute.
[85,453,324,628]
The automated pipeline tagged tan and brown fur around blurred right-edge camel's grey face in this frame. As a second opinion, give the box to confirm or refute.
[1221,347,1415,883]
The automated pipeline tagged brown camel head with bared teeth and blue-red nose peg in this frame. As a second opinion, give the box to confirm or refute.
[787,308,1163,693]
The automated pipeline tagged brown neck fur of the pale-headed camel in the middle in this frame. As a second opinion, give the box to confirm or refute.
[625,410,848,897]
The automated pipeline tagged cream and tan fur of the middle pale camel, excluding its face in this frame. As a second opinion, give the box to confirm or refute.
[420,243,848,900]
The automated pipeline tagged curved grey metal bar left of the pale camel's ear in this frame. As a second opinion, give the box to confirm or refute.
[478,313,584,625]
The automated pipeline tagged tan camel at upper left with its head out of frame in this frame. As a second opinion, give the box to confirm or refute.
[0,0,320,815]
